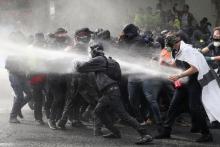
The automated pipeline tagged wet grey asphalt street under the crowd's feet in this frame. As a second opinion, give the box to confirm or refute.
[0,70,220,147]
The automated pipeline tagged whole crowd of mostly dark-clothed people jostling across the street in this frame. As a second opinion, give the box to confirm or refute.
[3,5,220,144]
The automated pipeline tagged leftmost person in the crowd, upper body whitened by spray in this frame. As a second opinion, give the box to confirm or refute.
[5,32,32,123]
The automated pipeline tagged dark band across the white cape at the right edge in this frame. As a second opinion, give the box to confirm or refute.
[199,69,220,87]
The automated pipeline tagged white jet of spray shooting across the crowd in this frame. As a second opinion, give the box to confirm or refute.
[0,37,180,78]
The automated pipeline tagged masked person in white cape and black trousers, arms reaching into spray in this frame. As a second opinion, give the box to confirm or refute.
[156,34,215,142]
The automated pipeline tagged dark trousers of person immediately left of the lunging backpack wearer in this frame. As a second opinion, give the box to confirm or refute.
[60,74,98,124]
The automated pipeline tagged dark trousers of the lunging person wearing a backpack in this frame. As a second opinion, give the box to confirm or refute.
[95,86,143,135]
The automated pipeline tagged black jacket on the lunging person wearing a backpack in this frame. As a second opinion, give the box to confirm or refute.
[76,56,117,91]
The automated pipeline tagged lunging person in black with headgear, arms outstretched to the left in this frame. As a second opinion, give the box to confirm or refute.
[76,43,153,144]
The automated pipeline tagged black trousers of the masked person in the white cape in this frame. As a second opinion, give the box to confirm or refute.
[164,80,209,134]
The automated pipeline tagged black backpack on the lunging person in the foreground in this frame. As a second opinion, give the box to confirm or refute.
[104,56,121,82]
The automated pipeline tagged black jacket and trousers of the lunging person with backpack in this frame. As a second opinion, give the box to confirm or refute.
[77,55,152,137]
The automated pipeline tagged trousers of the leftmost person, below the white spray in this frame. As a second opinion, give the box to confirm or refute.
[9,73,31,118]
